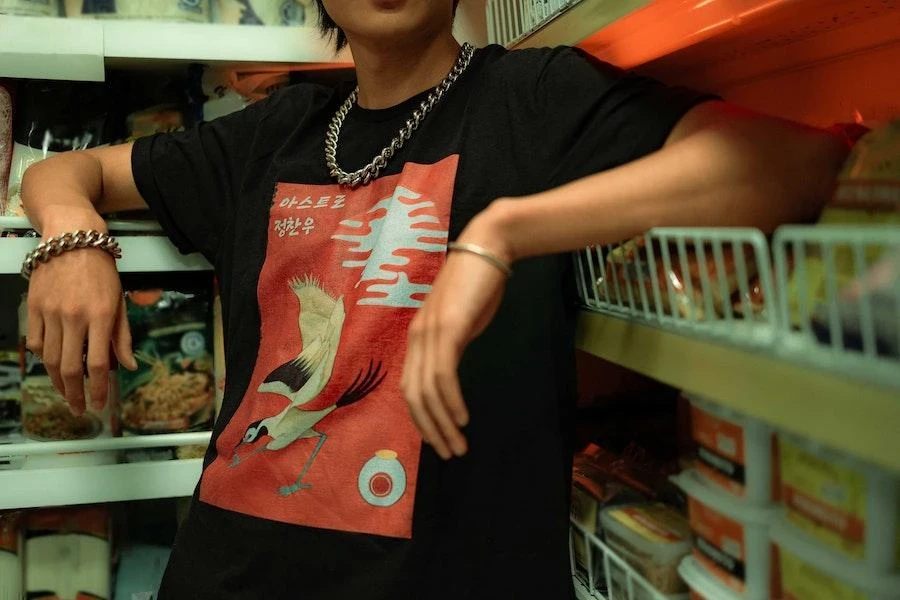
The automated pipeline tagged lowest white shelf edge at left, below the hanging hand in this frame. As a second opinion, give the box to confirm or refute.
[0,458,203,510]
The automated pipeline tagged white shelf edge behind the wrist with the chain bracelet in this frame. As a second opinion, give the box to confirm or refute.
[0,236,212,275]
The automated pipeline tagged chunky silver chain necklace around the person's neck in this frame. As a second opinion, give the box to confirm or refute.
[325,42,475,187]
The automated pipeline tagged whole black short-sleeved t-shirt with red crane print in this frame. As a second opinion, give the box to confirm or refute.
[132,46,701,600]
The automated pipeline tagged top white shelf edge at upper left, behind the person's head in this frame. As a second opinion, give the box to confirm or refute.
[0,16,351,81]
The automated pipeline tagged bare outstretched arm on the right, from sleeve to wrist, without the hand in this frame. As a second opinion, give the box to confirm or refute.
[476,110,846,260]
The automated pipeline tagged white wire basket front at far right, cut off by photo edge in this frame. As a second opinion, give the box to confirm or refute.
[773,225,900,388]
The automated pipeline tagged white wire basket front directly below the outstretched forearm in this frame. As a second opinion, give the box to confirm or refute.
[575,228,777,346]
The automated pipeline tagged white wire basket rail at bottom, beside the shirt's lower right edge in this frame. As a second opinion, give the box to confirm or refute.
[569,520,687,600]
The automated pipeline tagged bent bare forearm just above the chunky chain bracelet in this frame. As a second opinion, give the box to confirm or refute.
[22,152,106,236]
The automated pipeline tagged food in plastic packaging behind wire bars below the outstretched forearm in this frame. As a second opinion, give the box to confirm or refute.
[597,236,763,321]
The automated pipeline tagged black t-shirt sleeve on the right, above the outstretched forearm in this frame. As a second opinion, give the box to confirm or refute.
[529,48,715,186]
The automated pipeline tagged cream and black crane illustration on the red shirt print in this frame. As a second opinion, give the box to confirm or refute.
[231,277,385,496]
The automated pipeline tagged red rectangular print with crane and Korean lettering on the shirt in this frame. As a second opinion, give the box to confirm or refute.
[200,155,458,538]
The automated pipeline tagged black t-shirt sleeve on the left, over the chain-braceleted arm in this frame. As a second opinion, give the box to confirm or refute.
[131,95,269,262]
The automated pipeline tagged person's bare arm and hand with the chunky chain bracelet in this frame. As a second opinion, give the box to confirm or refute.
[22,144,147,414]
